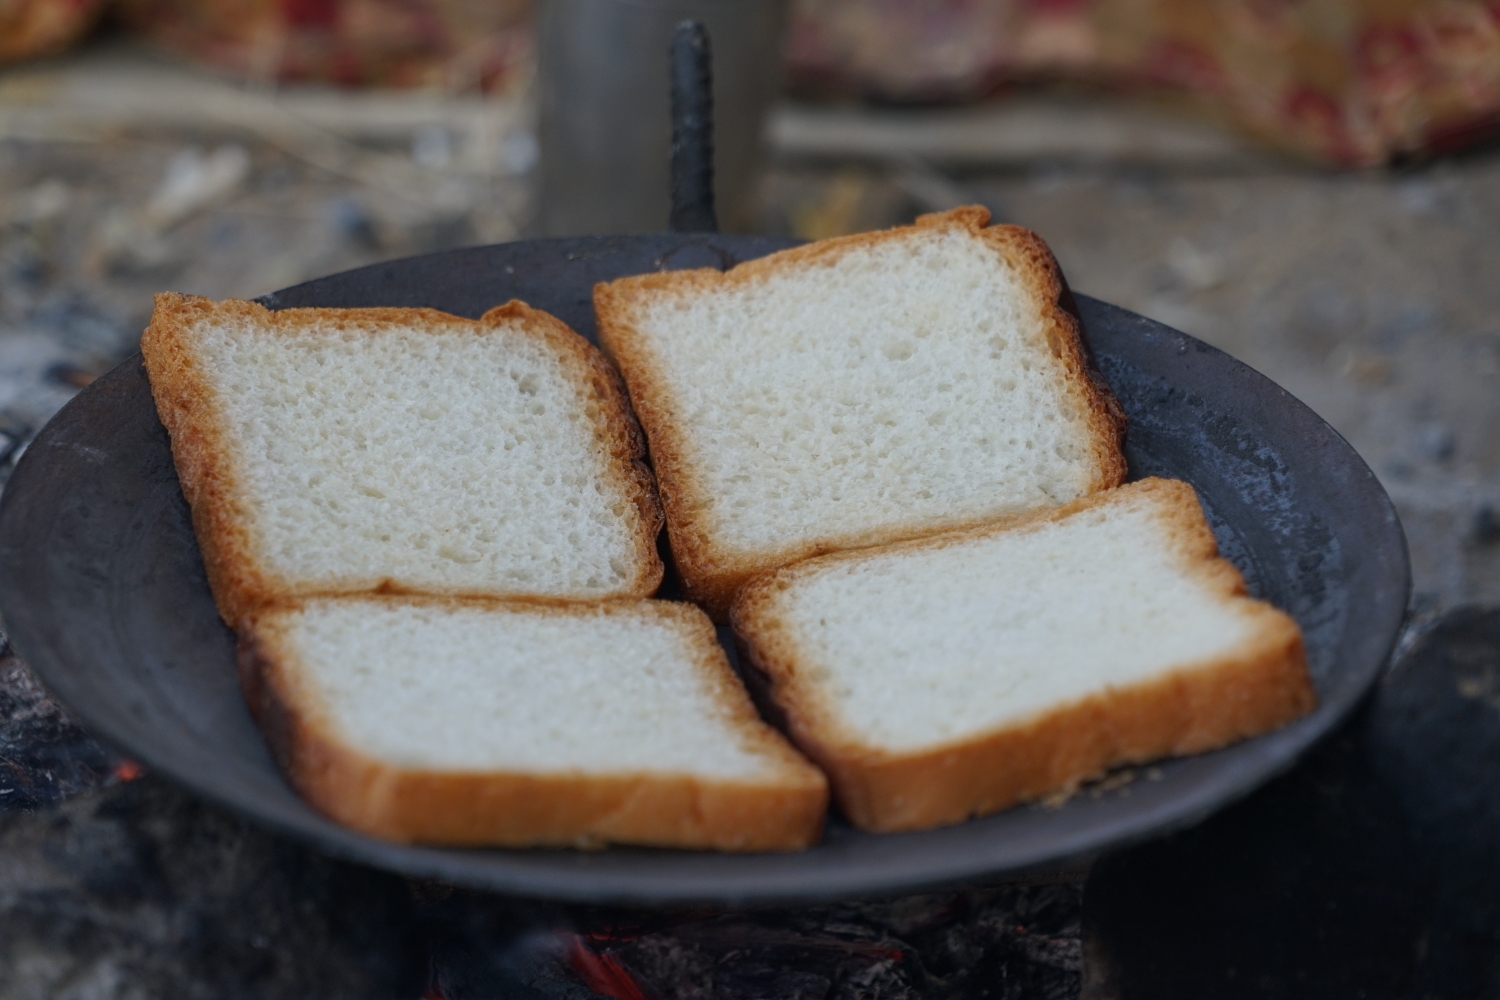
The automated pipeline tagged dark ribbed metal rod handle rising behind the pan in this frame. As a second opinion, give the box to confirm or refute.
[671,21,719,232]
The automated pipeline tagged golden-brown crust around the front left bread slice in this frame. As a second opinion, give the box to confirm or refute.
[239,595,828,852]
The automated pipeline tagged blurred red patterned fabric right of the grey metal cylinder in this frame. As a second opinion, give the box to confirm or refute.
[788,0,1500,166]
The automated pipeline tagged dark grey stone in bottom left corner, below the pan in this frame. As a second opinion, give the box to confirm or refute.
[0,778,426,1000]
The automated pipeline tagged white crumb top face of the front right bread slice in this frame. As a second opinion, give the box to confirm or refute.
[737,480,1305,753]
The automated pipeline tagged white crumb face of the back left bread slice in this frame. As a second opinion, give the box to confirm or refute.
[183,308,641,595]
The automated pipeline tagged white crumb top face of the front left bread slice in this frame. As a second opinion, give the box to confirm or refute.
[279,598,806,783]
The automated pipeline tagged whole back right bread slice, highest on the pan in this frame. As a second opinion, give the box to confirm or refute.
[594,207,1125,619]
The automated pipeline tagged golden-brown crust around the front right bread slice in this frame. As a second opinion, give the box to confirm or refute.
[732,480,1317,831]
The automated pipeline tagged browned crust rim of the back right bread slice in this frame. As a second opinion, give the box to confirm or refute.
[594,205,1125,622]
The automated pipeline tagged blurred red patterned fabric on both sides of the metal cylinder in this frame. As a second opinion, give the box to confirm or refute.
[0,0,1500,166]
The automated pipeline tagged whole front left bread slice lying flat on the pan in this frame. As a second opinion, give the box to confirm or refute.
[240,597,828,852]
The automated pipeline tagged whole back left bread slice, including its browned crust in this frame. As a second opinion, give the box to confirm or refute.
[141,294,662,625]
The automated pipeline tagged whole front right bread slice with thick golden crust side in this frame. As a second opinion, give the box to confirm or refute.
[734,480,1316,831]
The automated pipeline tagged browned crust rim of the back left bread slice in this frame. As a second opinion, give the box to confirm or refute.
[141,292,663,625]
